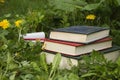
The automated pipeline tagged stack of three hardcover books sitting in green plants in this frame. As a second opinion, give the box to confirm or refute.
[44,26,120,68]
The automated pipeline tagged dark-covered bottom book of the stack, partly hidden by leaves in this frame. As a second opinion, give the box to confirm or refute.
[45,46,120,69]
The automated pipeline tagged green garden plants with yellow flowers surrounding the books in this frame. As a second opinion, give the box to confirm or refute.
[0,0,120,80]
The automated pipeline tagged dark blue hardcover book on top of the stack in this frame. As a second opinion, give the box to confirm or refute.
[49,26,110,43]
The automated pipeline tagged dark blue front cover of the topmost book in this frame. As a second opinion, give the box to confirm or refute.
[53,26,109,34]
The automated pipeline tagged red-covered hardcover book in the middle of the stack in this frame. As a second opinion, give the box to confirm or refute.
[45,37,112,56]
